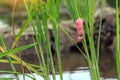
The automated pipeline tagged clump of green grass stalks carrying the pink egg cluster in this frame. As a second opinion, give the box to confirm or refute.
[66,0,100,80]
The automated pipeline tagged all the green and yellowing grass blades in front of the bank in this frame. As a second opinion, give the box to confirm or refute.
[0,0,120,80]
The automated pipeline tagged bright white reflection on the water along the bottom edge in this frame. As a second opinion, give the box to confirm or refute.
[0,70,117,80]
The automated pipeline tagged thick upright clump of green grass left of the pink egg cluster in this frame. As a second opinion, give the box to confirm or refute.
[24,0,62,80]
